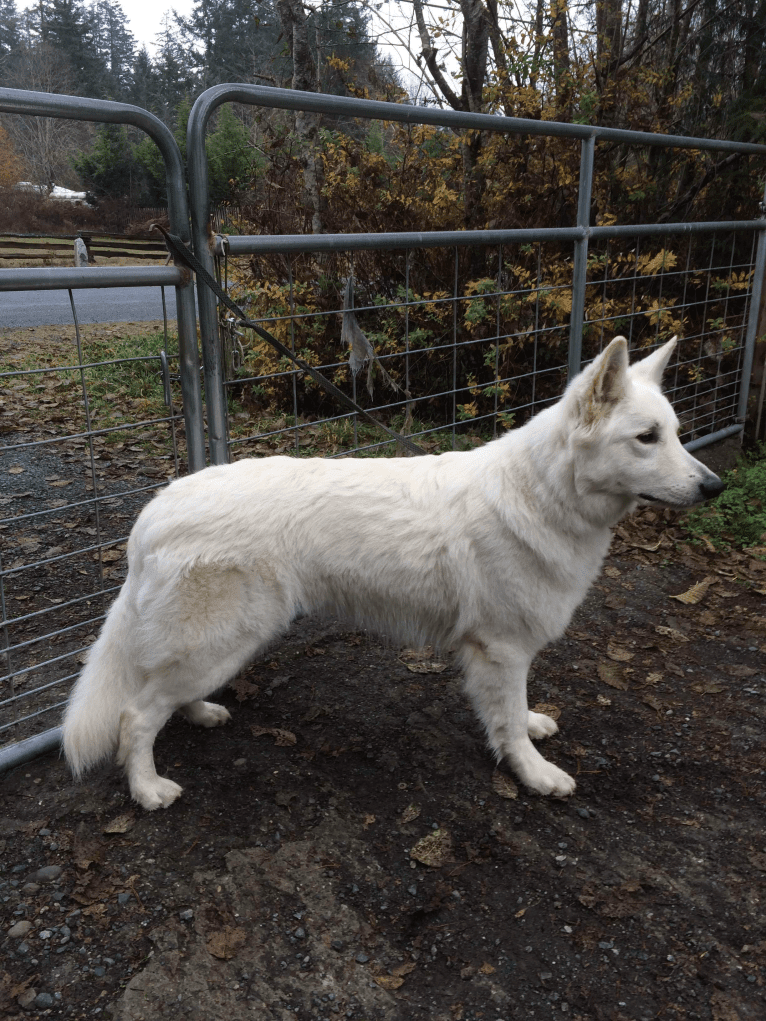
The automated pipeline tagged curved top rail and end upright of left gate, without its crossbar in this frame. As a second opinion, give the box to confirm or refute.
[0,89,205,472]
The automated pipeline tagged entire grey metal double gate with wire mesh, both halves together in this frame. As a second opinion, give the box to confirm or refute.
[0,85,766,768]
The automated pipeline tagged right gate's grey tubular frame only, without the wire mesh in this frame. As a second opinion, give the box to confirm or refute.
[187,83,766,465]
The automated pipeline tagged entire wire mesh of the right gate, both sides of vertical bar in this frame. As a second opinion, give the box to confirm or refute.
[214,231,756,458]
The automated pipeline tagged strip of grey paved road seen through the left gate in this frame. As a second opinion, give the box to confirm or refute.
[0,287,181,329]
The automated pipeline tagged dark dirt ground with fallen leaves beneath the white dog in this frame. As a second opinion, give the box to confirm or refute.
[0,439,766,1021]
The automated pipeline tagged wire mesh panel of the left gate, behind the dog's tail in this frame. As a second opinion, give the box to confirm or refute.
[0,291,187,744]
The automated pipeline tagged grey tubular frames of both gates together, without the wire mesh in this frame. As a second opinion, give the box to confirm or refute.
[0,84,766,768]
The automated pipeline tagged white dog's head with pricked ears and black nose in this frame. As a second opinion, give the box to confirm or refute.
[564,337,724,508]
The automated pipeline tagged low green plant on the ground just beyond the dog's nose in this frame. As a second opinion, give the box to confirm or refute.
[683,443,766,549]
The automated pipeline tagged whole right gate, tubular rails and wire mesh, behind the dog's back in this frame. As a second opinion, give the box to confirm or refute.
[187,84,766,464]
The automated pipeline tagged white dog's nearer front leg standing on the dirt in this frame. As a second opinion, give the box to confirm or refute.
[461,639,575,797]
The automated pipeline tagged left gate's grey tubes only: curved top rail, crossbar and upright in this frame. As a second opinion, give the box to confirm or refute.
[0,89,205,472]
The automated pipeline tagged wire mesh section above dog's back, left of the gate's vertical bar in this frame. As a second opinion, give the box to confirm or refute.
[216,238,580,458]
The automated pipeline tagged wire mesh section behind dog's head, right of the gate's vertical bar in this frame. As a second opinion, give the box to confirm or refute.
[583,231,757,442]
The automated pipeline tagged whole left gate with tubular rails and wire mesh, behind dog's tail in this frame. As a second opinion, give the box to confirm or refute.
[0,89,205,764]
